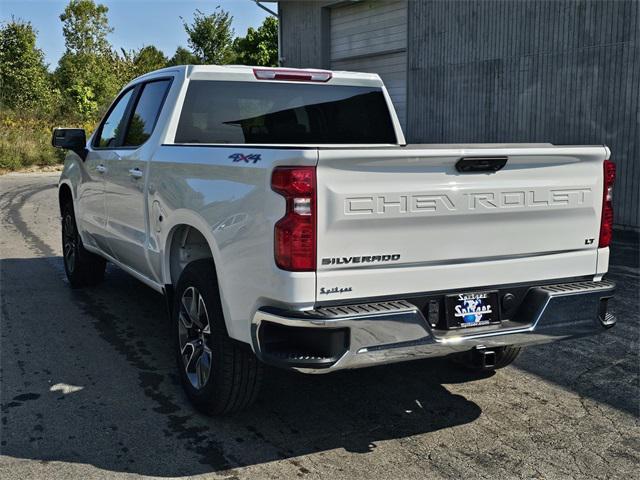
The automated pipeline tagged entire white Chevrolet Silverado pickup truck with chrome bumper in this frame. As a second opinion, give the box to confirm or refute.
[52,66,615,414]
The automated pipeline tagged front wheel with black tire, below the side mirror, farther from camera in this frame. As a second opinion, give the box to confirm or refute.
[62,202,107,288]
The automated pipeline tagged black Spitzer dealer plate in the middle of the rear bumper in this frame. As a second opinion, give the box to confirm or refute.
[445,291,500,329]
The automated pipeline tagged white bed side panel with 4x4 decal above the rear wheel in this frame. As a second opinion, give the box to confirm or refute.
[148,145,317,342]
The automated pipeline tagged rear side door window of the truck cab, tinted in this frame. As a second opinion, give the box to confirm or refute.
[123,80,171,147]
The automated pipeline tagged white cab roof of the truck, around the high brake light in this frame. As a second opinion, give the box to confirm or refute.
[125,65,382,87]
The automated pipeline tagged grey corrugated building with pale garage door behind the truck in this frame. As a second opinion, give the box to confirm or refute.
[278,0,640,230]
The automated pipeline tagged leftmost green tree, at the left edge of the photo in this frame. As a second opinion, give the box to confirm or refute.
[0,19,55,111]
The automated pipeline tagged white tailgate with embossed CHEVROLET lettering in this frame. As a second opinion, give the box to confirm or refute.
[317,145,608,302]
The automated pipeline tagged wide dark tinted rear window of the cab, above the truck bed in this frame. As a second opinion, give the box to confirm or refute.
[175,80,397,144]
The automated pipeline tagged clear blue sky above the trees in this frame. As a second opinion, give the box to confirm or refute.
[0,0,276,70]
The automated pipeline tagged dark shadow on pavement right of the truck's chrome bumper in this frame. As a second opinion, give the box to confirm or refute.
[515,231,640,416]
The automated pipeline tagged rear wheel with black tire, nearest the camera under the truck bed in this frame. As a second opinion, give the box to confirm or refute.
[172,259,263,415]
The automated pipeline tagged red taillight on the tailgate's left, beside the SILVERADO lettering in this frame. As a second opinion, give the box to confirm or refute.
[271,167,316,272]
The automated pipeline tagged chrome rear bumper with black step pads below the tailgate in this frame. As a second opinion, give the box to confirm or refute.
[252,281,616,373]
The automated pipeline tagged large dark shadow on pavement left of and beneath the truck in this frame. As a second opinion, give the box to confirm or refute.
[0,257,481,476]
